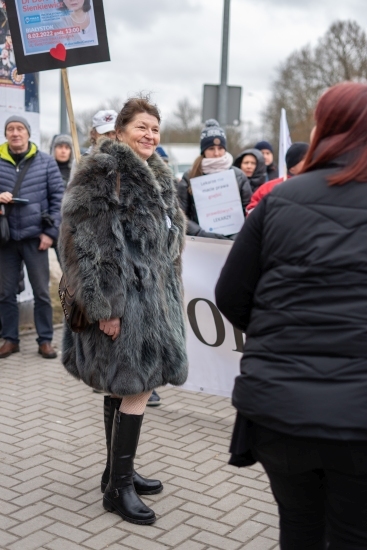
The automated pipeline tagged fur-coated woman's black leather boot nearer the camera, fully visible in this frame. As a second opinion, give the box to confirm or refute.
[103,411,156,525]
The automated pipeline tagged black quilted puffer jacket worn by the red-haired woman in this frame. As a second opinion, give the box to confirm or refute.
[217,158,367,440]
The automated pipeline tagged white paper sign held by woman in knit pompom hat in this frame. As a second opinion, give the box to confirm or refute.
[190,170,245,235]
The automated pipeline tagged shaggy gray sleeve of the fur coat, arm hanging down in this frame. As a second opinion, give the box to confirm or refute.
[59,154,126,322]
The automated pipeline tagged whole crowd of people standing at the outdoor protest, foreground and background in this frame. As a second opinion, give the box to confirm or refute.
[0,83,367,550]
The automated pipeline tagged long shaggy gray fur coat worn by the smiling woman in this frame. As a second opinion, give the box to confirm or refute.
[59,140,188,396]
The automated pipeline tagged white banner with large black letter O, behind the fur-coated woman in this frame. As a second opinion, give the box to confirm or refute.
[183,237,244,397]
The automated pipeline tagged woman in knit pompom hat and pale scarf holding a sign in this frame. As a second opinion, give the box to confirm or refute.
[177,118,252,239]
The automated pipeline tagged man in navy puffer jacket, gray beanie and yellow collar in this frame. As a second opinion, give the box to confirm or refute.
[0,115,64,359]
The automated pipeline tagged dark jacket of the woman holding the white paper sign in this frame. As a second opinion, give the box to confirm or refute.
[177,166,252,239]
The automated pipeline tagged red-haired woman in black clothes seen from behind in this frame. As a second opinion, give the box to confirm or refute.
[216,82,367,550]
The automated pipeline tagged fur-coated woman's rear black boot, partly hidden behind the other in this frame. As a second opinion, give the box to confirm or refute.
[101,395,163,495]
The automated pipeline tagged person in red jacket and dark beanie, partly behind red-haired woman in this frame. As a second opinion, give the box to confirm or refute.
[246,141,310,215]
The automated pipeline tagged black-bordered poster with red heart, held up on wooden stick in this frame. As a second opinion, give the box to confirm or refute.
[7,0,110,74]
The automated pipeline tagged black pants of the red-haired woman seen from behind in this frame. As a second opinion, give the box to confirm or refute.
[251,425,367,550]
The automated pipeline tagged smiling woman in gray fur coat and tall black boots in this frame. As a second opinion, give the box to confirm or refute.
[59,98,187,525]
